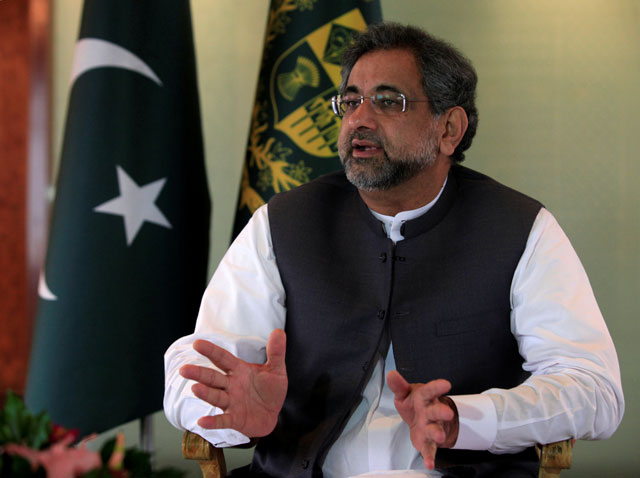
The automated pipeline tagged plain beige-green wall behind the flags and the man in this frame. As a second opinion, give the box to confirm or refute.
[54,0,640,477]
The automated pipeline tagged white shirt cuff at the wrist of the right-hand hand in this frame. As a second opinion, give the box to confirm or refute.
[450,395,498,450]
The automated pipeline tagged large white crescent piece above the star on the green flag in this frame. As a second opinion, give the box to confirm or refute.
[70,38,162,87]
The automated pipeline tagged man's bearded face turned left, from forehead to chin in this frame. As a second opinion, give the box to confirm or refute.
[338,50,439,191]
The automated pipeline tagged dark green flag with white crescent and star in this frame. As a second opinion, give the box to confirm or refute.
[26,0,210,435]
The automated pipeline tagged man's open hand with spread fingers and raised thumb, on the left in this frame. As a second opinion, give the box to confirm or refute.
[180,329,288,437]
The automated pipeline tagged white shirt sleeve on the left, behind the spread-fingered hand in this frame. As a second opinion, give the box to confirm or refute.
[164,205,285,447]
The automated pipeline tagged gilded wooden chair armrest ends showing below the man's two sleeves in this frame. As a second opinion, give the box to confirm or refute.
[182,431,573,478]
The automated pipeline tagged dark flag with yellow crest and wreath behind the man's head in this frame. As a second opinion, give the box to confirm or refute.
[233,0,382,237]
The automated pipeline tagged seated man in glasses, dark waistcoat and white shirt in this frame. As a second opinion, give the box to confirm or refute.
[165,24,624,477]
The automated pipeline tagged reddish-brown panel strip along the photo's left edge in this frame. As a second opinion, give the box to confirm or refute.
[0,2,32,403]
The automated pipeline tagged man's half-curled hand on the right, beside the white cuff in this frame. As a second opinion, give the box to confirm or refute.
[387,370,458,470]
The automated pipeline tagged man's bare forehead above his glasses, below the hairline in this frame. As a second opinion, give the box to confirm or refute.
[347,49,423,96]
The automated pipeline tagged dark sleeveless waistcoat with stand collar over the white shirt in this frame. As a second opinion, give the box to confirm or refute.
[252,166,541,477]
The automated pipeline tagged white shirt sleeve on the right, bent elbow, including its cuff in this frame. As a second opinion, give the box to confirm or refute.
[452,209,624,453]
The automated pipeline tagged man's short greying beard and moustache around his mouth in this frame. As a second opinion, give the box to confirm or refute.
[338,128,438,192]
